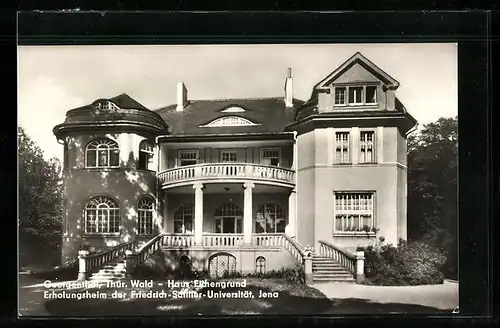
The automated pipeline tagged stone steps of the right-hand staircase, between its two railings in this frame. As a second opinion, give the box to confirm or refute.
[312,255,356,283]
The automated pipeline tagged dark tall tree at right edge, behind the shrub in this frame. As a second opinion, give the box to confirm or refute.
[408,117,458,277]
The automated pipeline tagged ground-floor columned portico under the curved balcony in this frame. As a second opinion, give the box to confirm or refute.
[161,181,296,246]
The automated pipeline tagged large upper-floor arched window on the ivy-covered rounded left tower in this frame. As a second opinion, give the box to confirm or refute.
[85,139,120,167]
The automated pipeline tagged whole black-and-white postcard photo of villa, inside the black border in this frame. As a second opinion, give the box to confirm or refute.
[17,43,459,317]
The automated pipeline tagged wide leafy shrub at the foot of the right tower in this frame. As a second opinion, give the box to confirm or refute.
[364,240,446,286]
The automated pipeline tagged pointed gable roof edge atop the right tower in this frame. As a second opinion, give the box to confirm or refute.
[314,52,399,89]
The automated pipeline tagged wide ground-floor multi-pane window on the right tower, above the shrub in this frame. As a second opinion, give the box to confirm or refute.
[332,190,377,237]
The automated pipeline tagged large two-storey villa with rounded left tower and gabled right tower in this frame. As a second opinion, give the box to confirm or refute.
[54,53,417,271]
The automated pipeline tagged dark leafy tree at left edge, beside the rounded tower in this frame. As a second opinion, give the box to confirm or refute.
[18,128,63,264]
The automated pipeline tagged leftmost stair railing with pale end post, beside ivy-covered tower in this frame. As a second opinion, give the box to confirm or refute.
[78,241,136,280]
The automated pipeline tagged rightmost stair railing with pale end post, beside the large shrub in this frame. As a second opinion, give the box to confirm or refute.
[319,240,365,282]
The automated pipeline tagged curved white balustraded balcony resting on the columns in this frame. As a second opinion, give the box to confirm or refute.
[158,163,295,189]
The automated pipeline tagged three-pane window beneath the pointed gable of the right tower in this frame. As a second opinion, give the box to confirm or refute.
[335,85,377,106]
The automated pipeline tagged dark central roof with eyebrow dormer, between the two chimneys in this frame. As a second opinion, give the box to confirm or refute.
[155,97,304,135]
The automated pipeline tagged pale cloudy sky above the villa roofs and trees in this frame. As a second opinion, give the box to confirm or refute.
[18,43,458,159]
